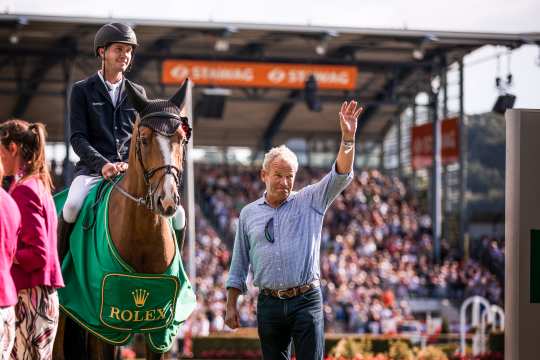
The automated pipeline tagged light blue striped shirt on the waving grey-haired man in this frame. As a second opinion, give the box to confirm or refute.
[226,164,353,293]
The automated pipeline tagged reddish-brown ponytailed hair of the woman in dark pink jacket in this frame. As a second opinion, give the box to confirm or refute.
[0,119,53,192]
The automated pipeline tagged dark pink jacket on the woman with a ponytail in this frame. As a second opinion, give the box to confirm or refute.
[10,177,64,290]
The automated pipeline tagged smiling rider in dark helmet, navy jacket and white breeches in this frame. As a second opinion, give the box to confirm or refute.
[58,23,183,253]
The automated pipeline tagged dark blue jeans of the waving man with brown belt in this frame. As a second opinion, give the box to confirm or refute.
[257,288,324,360]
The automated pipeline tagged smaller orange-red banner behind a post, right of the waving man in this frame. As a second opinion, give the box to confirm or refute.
[411,118,459,170]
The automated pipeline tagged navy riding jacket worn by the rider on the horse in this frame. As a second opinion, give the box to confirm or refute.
[69,72,146,176]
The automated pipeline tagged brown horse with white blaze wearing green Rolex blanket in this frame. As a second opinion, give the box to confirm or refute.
[55,75,196,359]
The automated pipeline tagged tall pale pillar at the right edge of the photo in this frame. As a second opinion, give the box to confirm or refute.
[504,109,540,360]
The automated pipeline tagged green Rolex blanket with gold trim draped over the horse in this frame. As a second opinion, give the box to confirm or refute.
[55,182,196,353]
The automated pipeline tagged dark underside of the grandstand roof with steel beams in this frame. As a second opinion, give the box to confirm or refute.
[0,15,540,148]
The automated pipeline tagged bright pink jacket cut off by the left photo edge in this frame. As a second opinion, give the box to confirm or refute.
[0,188,21,307]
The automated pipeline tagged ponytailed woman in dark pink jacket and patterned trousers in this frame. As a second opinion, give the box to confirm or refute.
[0,120,64,360]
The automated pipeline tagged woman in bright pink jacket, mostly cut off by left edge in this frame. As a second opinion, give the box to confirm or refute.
[0,162,21,360]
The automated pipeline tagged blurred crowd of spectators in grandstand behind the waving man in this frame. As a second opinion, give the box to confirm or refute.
[193,165,504,334]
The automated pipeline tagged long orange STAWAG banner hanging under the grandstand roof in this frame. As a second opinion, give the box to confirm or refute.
[161,60,358,90]
